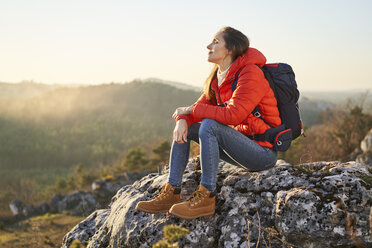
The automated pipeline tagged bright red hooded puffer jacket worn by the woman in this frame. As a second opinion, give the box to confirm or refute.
[177,48,281,148]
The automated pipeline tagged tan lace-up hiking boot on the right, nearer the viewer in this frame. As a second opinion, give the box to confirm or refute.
[169,184,216,220]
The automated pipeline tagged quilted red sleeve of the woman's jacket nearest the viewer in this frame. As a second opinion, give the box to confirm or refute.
[193,66,270,125]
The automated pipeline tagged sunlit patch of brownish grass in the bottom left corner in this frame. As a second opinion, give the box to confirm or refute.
[0,214,84,248]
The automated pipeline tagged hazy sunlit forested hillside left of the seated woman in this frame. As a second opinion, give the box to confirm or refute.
[0,81,200,171]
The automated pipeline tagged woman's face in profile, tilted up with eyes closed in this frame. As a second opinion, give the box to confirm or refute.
[207,33,231,64]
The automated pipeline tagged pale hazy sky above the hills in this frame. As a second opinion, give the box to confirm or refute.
[0,0,372,91]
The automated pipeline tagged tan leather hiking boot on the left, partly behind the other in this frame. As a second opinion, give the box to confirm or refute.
[136,183,181,214]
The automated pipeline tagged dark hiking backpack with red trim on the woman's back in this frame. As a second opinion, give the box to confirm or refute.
[231,63,304,152]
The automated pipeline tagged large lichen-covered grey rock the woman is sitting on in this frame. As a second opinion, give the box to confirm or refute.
[62,161,372,248]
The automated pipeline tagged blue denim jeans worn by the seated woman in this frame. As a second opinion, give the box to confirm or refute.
[168,119,277,191]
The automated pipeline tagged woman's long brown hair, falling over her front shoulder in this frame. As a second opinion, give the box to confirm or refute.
[204,27,249,101]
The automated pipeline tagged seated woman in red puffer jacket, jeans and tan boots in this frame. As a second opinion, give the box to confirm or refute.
[136,27,281,219]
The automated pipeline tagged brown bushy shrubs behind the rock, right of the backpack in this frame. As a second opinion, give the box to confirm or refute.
[280,99,372,164]
